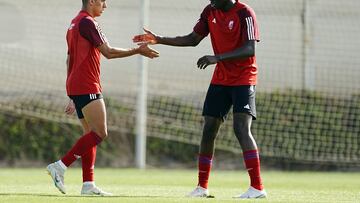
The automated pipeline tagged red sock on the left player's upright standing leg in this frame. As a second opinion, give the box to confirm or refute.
[81,146,96,182]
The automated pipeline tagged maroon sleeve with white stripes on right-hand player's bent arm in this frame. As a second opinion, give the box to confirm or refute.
[239,7,260,41]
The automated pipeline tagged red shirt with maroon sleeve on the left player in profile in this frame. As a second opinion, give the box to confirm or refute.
[66,11,107,95]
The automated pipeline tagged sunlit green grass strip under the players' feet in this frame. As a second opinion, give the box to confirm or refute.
[0,168,360,203]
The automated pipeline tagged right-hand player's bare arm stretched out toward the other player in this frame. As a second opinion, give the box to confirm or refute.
[133,29,204,46]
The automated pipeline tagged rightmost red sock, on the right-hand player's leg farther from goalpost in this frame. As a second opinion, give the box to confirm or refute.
[243,150,264,190]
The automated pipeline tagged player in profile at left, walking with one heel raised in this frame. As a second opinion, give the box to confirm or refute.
[47,0,159,196]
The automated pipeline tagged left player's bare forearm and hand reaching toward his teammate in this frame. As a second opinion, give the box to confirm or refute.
[98,43,159,59]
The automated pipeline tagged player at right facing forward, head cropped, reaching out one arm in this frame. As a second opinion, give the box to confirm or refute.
[133,0,266,198]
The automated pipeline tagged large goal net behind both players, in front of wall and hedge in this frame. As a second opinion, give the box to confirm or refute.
[0,0,360,166]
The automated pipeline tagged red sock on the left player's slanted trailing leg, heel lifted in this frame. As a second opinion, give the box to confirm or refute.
[61,131,102,167]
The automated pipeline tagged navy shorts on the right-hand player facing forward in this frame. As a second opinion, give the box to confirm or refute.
[202,85,256,121]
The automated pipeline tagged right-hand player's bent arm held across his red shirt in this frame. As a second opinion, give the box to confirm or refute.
[197,40,256,69]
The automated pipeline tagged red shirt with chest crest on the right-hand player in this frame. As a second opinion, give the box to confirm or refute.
[194,1,260,86]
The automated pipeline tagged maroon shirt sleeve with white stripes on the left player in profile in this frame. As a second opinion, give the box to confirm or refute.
[79,18,107,47]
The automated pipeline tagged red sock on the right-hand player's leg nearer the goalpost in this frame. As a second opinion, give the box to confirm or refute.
[198,154,213,189]
